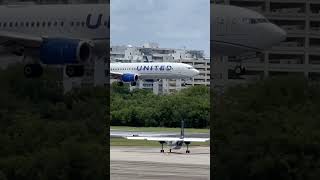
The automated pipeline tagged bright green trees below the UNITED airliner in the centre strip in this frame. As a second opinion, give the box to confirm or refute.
[110,83,210,128]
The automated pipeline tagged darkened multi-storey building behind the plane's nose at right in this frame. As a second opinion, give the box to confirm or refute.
[211,0,320,89]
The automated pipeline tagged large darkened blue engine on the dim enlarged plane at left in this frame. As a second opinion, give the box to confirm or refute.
[40,38,91,64]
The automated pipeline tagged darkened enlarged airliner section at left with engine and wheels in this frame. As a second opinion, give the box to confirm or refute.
[0,3,110,77]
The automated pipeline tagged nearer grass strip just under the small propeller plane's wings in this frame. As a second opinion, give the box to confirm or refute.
[110,138,210,147]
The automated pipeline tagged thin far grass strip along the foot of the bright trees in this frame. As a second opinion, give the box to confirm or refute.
[110,126,210,133]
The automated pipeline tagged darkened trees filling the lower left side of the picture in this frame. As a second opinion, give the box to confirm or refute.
[0,65,109,180]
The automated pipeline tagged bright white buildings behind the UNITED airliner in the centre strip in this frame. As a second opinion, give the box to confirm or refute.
[110,43,210,94]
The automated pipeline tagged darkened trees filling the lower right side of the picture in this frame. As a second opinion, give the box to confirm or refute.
[211,76,320,180]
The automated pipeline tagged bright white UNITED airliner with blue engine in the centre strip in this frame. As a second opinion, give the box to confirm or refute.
[110,62,199,86]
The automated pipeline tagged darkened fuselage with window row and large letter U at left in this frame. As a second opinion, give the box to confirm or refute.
[0,4,110,52]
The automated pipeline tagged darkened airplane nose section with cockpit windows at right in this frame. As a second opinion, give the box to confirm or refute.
[210,4,286,57]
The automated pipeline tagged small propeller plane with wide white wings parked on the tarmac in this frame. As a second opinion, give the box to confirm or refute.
[125,120,210,153]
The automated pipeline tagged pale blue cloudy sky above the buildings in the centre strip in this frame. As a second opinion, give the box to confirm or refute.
[110,0,210,57]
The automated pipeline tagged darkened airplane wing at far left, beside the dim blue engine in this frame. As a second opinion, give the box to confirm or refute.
[0,31,43,47]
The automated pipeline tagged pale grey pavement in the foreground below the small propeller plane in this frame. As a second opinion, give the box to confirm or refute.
[110,147,210,180]
